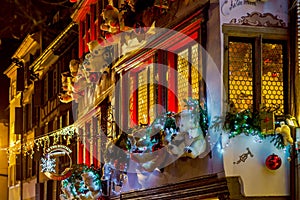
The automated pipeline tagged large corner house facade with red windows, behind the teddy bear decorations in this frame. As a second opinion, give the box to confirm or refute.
[65,1,299,199]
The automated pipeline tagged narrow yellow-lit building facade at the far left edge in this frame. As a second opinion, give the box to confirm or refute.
[4,34,40,199]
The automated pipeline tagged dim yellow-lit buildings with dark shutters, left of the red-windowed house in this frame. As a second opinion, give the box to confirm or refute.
[4,12,77,199]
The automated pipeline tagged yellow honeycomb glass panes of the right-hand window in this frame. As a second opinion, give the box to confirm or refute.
[228,38,286,114]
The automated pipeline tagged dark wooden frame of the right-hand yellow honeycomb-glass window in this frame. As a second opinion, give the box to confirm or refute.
[222,24,291,113]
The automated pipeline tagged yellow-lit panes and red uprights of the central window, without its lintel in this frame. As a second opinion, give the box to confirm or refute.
[128,48,204,127]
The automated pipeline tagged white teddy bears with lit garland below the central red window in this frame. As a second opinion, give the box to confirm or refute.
[104,98,208,172]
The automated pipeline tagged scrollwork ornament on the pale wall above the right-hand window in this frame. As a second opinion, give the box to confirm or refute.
[230,12,287,27]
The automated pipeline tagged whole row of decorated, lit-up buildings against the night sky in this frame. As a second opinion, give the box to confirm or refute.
[5,0,299,199]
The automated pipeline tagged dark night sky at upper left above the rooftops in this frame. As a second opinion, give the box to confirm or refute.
[0,0,73,116]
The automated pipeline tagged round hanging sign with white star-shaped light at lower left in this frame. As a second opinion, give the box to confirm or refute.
[41,145,72,181]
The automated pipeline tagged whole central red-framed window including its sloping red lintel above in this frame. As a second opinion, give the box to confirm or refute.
[121,18,205,130]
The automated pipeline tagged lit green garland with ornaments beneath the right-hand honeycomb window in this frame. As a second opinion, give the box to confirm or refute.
[212,102,294,149]
